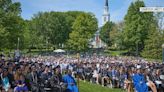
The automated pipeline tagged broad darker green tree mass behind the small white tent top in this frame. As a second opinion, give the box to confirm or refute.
[31,11,83,48]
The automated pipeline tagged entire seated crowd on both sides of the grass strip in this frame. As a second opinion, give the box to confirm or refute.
[0,52,164,92]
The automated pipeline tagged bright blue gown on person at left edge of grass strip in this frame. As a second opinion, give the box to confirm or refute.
[63,74,78,92]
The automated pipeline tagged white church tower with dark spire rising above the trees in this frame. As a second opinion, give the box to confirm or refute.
[102,0,110,26]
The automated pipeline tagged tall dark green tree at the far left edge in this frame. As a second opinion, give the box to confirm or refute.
[0,0,23,49]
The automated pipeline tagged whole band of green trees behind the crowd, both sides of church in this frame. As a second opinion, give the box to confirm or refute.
[0,0,164,59]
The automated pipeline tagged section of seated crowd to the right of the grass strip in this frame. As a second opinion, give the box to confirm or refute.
[75,56,164,92]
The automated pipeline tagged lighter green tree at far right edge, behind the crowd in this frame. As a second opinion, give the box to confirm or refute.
[141,26,164,59]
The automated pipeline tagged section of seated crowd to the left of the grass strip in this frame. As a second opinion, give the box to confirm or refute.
[0,54,78,92]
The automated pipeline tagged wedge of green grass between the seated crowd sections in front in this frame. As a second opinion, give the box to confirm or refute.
[79,81,124,92]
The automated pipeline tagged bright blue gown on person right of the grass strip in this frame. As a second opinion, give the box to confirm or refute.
[132,74,148,92]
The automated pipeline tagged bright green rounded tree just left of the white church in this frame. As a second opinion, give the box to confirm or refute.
[67,13,98,51]
